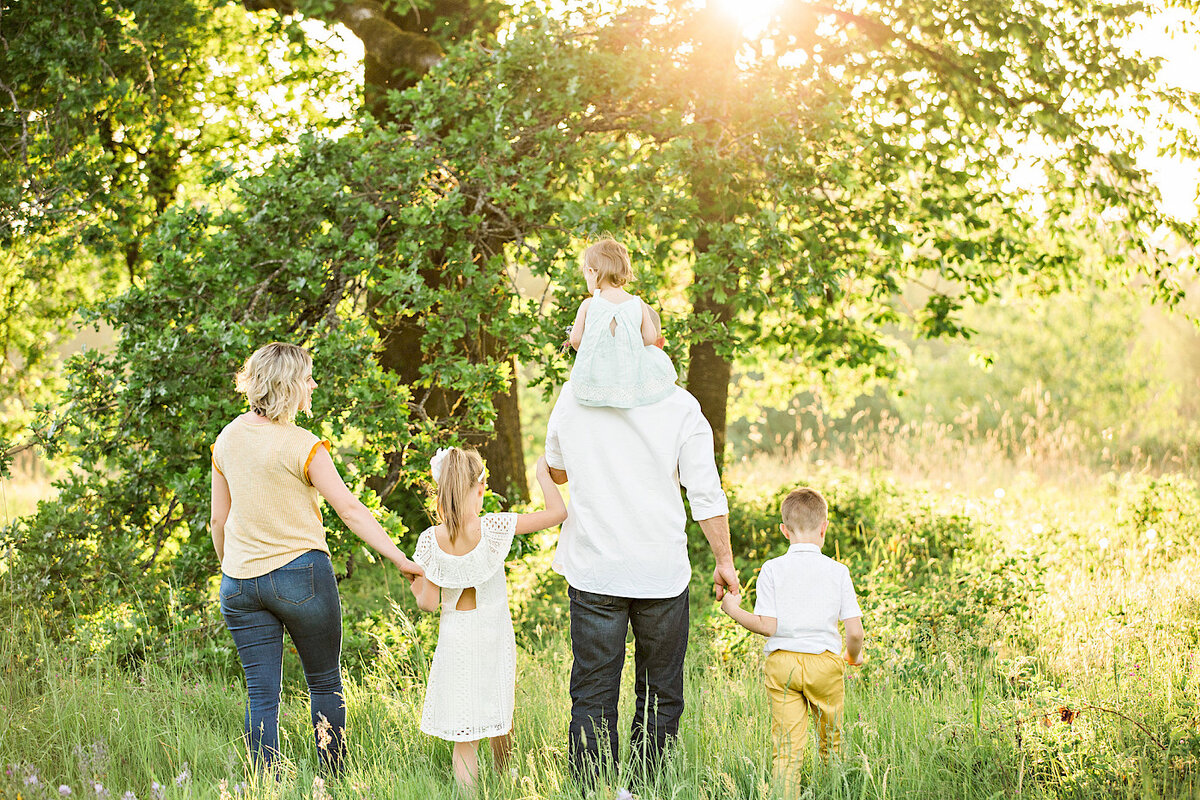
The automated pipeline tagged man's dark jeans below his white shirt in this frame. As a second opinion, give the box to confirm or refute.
[568,587,689,780]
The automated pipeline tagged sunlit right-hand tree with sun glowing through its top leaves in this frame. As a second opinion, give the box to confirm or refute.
[564,0,1198,455]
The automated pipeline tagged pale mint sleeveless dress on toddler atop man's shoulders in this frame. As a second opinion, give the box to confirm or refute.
[571,294,677,408]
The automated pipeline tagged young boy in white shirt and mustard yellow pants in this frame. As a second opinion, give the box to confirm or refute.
[721,488,863,780]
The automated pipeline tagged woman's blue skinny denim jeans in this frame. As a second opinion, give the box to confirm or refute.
[221,551,346,772]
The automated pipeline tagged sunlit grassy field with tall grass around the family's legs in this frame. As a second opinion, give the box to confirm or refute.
[0,445,1200,800]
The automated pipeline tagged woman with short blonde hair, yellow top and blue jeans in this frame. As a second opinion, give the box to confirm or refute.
[211,342,422,772]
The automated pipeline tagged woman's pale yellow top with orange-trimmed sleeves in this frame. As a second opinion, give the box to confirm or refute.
[212,416,329,578]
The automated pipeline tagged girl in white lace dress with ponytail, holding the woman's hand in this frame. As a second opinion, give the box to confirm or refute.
[412,447,566,787]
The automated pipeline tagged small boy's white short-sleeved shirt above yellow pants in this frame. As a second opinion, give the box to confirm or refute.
[754,543,863,654]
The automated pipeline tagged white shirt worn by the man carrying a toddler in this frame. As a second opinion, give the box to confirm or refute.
[546,381,730,599]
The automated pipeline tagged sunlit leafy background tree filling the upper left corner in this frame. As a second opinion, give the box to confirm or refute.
[0,0,353,441]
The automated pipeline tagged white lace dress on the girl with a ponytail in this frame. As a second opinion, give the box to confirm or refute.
[413,513,517,741]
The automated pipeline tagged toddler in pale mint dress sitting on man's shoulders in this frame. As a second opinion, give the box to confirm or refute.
[570,239,677,408]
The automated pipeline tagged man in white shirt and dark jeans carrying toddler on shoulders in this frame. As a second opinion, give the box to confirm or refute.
[546,381,738,778]
